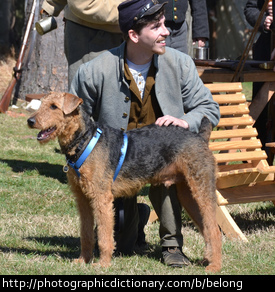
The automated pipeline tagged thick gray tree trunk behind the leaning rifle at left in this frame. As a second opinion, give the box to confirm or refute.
[14,0,68,100]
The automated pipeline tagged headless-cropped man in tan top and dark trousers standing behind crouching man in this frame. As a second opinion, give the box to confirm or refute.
[41,0,123,88]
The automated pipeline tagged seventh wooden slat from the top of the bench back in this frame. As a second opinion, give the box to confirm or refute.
[214,151,267,163]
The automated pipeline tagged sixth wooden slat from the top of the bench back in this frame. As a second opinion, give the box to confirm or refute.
[209,139,262,151]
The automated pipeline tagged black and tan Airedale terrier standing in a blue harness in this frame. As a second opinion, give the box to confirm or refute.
[28,93,221,272]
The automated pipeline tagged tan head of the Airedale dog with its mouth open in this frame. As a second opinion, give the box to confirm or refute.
[28,92,83,143]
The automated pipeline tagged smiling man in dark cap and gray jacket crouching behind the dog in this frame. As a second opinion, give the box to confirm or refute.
[71,0,220,267]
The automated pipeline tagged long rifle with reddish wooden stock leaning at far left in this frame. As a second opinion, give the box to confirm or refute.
[0,0,37,113]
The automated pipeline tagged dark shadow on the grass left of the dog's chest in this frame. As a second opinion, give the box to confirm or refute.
[0,158,67,184]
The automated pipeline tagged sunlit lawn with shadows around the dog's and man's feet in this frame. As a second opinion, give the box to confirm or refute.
[0,106,275,275]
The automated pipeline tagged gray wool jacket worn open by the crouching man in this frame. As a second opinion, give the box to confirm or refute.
[70,42,220,132]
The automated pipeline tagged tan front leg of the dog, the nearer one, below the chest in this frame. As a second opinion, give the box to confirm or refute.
[93,190,115,267]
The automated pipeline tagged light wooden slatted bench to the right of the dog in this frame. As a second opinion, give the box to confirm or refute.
[205,83,275,241]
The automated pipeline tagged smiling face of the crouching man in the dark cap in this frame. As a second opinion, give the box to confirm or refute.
[138,16,170,55]
